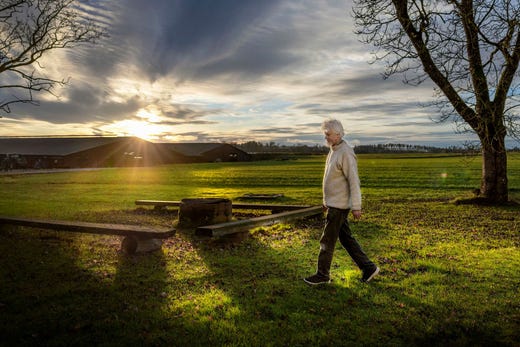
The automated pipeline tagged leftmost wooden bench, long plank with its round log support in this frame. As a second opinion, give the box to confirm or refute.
[0,216,176,254]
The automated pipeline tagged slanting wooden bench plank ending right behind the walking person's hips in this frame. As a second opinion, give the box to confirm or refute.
[196,206,323,236]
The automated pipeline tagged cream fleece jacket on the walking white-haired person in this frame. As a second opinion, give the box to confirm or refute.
[323,141,361,211]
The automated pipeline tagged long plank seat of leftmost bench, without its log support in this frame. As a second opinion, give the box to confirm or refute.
[0,216,175,239]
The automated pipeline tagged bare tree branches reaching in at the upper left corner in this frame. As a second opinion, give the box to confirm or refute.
[0,0,104,113]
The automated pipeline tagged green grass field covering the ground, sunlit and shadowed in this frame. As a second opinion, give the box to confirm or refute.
[0,154,520,346]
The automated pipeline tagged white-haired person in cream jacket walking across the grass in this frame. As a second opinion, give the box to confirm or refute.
[304,118,379,285]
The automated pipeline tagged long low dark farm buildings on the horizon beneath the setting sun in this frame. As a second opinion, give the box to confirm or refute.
[0,136,250,170]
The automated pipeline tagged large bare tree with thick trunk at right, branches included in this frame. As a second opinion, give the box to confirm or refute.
[353,0,520,203]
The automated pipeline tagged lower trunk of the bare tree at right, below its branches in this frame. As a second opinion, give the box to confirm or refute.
[480,136,509,203]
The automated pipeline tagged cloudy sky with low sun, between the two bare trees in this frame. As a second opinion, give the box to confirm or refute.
[0,0,488,146]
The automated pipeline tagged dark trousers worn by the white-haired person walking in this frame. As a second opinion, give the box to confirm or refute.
[318,207,375,277]
